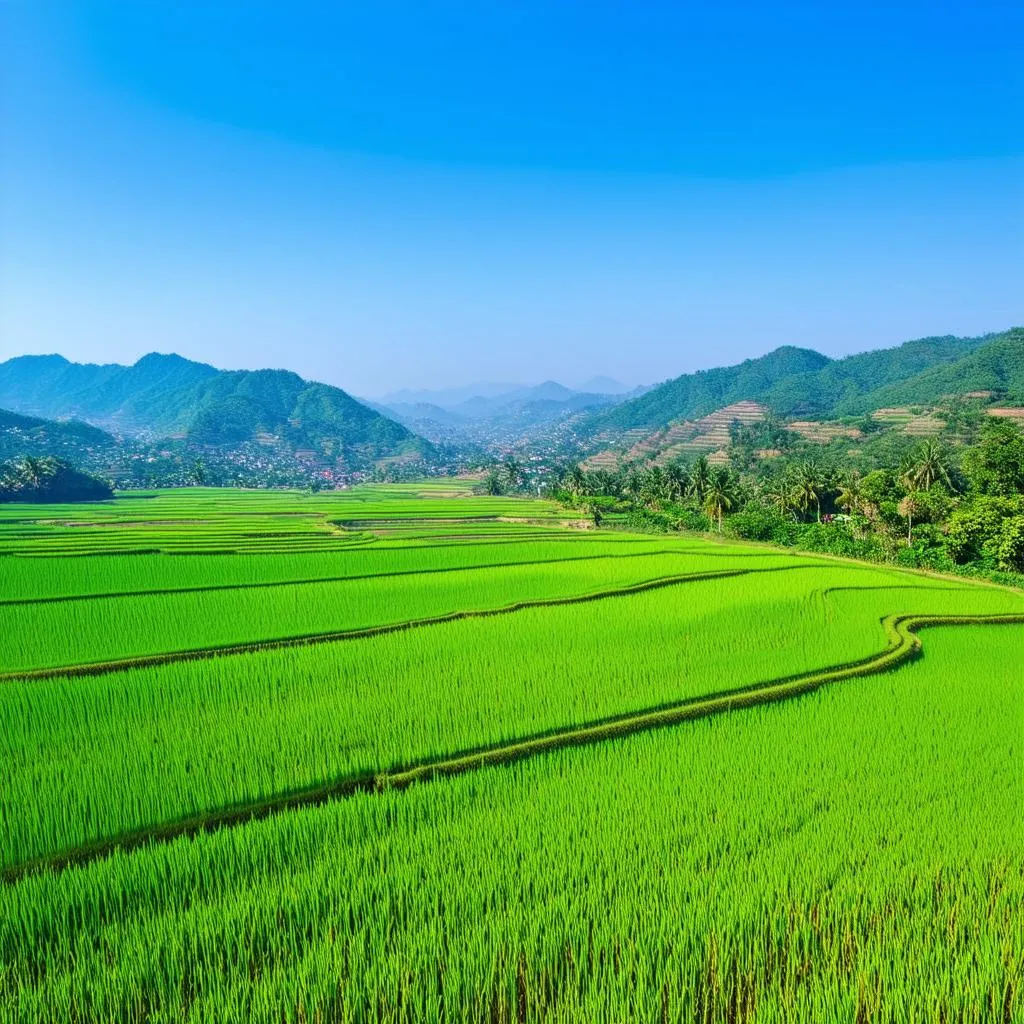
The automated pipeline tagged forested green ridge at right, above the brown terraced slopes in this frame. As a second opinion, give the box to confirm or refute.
[582,328,1011,433]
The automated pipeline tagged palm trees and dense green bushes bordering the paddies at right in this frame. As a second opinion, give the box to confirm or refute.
[548,412,1024,575]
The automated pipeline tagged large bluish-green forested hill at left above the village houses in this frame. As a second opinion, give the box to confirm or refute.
[0,353,430,465]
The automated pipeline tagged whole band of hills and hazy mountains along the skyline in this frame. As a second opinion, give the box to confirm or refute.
[0,328,1024,472]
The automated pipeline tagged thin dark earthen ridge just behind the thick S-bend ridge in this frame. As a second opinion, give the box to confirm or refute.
[0,565,813,683]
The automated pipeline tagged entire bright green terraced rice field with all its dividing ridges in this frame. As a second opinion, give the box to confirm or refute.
[0,482,1024,1024]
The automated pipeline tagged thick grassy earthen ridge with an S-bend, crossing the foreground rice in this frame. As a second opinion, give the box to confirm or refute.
[0,606,1024,884]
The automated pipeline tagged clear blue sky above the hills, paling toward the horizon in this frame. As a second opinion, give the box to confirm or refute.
[0,0,1024,395]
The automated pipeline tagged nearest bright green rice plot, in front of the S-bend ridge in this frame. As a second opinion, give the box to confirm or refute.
[0,628,1024,1024]
